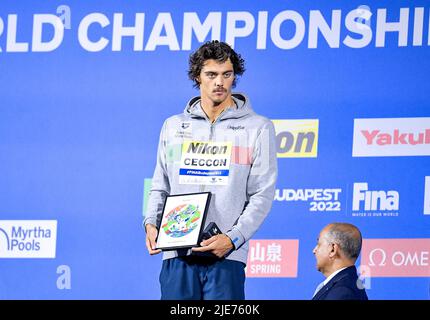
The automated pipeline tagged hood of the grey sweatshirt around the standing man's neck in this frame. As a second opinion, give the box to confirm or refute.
[184,93,254,120]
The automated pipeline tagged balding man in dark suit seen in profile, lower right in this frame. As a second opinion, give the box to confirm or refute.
[312,223,367,300]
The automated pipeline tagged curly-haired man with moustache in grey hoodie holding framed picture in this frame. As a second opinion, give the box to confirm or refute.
[144,41,277,300]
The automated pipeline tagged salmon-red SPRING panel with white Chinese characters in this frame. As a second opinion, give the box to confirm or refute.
[246,240,299,278]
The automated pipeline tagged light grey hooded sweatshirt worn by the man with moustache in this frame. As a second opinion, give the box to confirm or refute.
[144,93,277,264]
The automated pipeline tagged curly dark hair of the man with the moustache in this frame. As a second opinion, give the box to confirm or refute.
[188,40,245,88]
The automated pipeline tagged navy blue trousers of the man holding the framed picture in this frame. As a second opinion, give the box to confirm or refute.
[160,257,245,300]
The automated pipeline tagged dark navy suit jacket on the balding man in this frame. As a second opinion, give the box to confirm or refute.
[312,266,368,300]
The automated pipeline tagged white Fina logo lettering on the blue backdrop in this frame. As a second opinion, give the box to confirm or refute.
[352,182,399,216]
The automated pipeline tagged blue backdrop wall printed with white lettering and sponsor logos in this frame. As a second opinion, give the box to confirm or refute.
[0,0,430,299]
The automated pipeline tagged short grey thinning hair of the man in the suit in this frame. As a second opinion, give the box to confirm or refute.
[326,222,362,261]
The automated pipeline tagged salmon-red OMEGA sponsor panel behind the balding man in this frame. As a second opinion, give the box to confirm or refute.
[361,239,430,277]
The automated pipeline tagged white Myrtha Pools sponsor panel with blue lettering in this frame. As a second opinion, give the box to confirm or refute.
[0,220,57,258]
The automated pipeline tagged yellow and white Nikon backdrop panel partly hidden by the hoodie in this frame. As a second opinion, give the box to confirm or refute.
[272,119,318,158]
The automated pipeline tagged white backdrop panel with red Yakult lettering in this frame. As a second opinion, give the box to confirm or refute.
[352,117,430,157]
